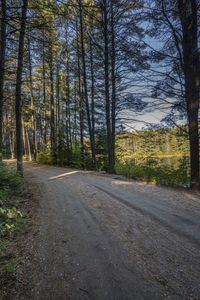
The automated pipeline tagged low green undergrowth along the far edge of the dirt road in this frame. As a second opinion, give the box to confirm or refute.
[38,149,190,187]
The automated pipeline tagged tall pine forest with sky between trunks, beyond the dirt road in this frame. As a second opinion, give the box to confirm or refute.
[0,0,200,188]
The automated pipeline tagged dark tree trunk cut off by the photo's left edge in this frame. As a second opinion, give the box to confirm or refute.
[0,0,6,164]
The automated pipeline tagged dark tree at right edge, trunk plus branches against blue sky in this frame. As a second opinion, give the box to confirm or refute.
[146,0,200,188]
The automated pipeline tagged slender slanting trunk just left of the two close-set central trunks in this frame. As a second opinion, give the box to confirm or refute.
[79,0,96,169]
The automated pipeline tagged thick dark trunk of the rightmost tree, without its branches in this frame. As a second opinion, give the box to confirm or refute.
[178,0,200,188]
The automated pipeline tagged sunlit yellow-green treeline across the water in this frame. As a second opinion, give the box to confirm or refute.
[117,127,189,161]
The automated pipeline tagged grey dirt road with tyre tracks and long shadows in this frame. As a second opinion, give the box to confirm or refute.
[9,163,200,300]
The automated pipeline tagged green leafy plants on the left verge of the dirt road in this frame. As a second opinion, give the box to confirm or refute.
[0,166,27,273]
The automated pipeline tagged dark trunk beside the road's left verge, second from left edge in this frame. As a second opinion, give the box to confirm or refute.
[15,0,28,176]
